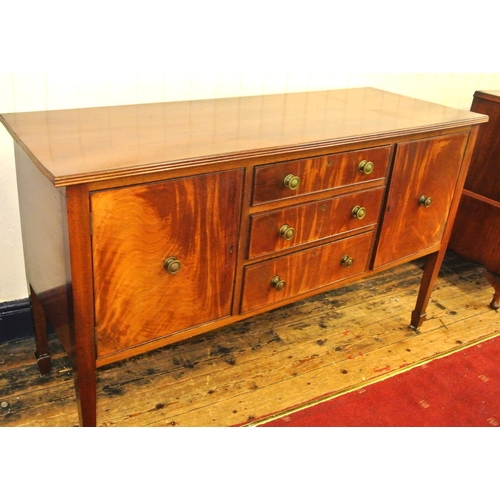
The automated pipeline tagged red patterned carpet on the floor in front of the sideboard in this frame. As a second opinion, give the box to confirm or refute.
[261,337,500,427]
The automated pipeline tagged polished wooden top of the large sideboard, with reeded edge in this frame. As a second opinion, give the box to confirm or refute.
[0,88,488,186]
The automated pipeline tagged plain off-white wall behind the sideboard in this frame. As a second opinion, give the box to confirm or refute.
[0,0,500,303]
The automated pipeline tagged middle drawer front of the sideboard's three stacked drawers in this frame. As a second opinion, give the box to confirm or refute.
[247,188,384,259]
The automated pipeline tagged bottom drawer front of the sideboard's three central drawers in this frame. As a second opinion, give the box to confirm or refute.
[241,232,373,313]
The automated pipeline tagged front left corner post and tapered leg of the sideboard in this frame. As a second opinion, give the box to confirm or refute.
[66,185,97,427]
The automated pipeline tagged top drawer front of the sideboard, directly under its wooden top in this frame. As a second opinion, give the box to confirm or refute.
[253,146,391,205]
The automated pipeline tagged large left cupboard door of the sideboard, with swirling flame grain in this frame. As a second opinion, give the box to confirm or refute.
[91,170,243,357]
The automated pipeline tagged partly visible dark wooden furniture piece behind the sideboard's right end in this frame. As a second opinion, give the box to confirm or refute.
[450,90,500,309]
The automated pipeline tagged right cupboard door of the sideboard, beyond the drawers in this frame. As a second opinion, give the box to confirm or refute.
[374,133,468,268]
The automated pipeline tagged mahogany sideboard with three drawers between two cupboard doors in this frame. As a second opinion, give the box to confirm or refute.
[1,88,487,426]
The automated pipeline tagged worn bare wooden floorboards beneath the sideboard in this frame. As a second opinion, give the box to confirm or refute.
[0,252,500,427]
